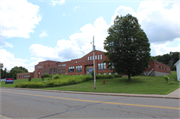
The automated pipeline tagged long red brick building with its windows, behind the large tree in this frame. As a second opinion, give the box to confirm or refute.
[17,50,171,79]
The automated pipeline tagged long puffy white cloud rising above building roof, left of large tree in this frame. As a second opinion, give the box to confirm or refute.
[29,17,109,61]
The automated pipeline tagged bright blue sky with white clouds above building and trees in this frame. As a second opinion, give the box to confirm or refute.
[0,0,180,72]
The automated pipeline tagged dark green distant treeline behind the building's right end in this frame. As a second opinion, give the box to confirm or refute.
[150,52,179,70]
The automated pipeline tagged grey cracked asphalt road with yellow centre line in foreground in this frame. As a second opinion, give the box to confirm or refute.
[0,88,180,119]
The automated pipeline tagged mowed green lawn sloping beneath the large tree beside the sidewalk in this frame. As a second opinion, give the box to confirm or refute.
[42,71,179,94]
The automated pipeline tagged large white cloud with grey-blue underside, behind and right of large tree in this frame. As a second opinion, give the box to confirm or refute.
[111,0,180,56]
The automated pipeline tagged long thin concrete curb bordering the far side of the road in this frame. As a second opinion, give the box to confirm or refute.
[0,87,180,99]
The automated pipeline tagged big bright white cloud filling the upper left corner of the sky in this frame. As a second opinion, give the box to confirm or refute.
[0,0,41,38]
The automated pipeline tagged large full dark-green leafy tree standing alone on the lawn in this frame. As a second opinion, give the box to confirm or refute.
[104,14,150,81]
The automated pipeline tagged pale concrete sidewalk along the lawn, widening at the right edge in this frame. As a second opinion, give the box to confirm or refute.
[1,88,180,99]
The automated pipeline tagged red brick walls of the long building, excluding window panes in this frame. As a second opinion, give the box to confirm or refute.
[31,50,171,78]
